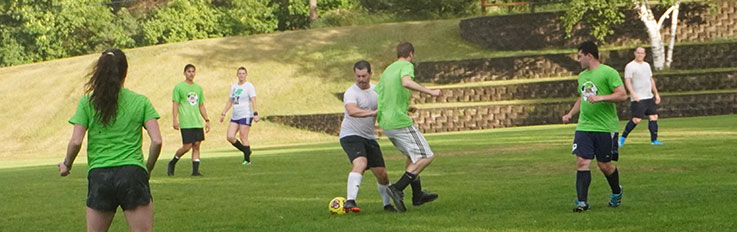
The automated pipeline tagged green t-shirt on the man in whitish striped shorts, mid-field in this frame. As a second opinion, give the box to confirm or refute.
[374,61,415,130]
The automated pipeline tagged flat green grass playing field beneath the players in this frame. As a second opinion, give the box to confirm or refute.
[0,115,737,231]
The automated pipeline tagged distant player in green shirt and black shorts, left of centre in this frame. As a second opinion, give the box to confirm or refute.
[167,64,210,176]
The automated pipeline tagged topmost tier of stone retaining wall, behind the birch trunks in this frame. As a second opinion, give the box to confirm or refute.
[460,1,737,50]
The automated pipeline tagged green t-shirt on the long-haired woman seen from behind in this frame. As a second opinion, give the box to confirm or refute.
[69,88,159,171]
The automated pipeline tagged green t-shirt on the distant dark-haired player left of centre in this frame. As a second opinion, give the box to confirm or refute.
[171,81,205,129]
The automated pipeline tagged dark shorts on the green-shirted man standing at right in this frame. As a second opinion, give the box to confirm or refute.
[572,131,619,163]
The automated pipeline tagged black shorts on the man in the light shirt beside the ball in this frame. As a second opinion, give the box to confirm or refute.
[340,135,384,168]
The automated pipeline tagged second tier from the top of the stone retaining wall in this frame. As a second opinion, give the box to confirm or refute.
[415,42,737,84]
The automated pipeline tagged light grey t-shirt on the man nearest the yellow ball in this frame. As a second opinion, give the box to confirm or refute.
[340,84,378,140]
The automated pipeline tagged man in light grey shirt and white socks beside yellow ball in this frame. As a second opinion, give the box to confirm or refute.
[340,60,396,212]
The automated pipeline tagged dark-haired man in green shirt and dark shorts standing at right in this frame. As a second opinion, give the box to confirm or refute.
[562,41,627,212]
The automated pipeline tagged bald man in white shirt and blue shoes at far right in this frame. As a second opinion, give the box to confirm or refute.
[619,47,663,147]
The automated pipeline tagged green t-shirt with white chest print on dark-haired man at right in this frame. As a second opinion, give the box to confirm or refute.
[576,64,622,132]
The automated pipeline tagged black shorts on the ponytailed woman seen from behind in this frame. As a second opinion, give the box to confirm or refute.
[87,165,153,212]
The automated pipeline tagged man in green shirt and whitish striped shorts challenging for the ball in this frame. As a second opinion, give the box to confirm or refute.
[375,42,441,212]
